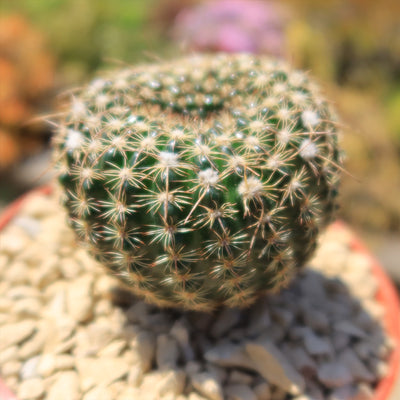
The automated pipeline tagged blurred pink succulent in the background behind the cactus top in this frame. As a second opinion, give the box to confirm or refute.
[172,0,286,56]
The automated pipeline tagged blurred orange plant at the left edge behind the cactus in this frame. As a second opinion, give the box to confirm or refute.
[0,15,54,169]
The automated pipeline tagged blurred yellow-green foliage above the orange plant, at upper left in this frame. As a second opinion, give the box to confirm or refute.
[0,0,170,84]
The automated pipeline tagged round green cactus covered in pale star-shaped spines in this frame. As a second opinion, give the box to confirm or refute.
[54,54,341,310]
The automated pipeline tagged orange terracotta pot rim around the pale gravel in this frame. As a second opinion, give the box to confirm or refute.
[0,186,400,400]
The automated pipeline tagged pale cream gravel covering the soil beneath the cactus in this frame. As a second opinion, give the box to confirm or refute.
[0,194,391,400]
